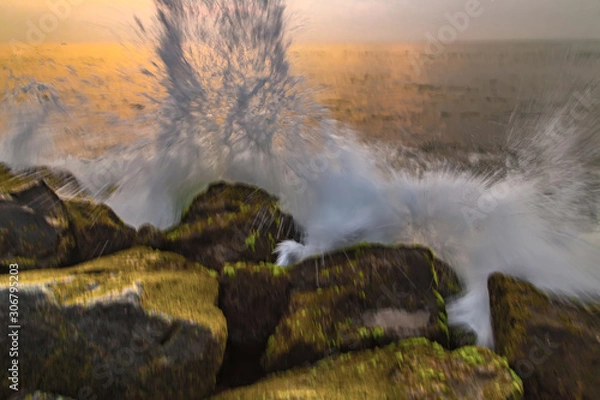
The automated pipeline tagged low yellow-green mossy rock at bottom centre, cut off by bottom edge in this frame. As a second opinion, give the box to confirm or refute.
[212,338,523,400]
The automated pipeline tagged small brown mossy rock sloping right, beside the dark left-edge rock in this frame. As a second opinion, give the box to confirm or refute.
[64,200,136,264]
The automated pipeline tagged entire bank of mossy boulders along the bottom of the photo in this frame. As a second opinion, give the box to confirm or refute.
[0,166,600,400]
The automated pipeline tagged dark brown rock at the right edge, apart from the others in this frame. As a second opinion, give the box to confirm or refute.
[489,275,600,400]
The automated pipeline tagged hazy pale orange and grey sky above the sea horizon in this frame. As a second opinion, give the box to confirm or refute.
[0,0,600,42]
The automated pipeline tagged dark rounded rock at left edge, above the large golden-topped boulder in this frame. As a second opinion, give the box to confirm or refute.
[0,181,75,269]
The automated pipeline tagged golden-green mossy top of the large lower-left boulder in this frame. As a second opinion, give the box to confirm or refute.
[10,247,226,337]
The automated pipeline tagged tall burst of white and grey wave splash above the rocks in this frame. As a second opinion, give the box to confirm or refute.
[2,0,600,346]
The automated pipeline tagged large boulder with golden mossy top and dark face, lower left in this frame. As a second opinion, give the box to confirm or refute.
[0,248,227,399]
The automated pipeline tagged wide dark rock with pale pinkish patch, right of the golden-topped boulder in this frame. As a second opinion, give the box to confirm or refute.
[220,245,458,383]
